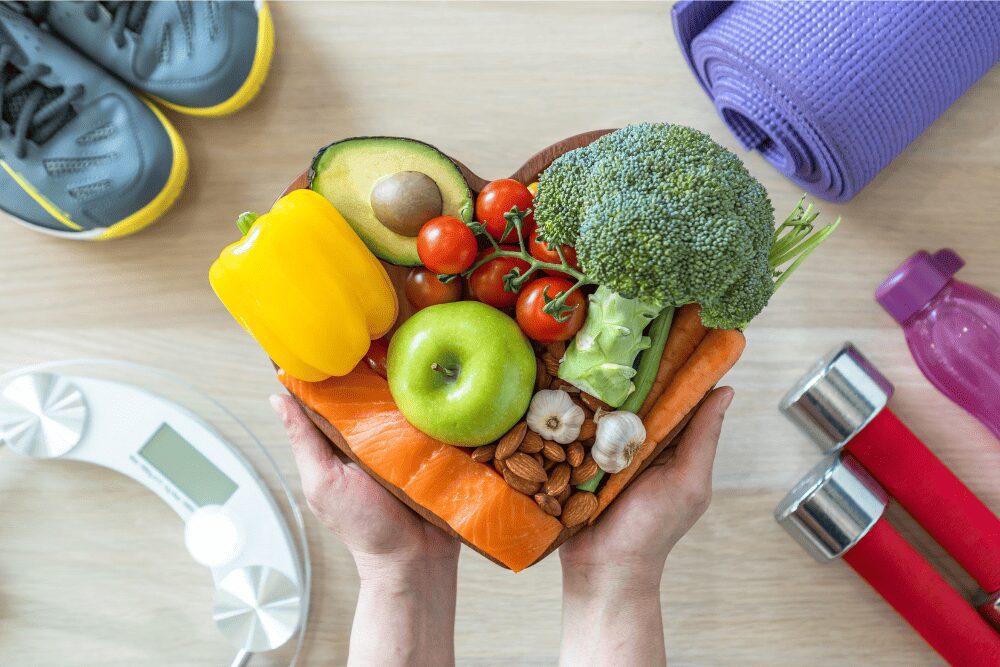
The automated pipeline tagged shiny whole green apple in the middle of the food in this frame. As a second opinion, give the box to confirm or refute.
[387,301,535,447]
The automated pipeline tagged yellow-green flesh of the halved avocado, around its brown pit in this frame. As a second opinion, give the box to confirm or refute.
[309,137,474,266]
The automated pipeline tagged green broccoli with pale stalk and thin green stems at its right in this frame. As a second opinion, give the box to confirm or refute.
[534,124,837,406]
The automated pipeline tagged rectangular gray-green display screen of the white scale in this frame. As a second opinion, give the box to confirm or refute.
[139,424,237,507]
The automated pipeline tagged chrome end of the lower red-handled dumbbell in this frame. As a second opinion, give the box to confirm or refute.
[774,455,889,563]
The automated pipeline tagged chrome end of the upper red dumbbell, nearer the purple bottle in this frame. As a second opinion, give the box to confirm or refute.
[778,343,893,452]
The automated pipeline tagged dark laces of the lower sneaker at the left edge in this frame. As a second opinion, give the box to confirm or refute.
[0,44,83,159]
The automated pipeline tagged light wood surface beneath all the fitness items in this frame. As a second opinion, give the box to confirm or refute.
[0,3,1000,666]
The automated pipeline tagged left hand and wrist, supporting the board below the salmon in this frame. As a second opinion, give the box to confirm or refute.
[270,396,459,665]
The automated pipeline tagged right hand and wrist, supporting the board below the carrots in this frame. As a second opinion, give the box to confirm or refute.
[559,387,733,665]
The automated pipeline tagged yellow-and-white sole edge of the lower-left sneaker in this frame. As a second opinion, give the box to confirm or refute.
[0,97,188,241]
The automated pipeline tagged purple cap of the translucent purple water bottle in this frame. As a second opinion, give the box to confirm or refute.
[875,248,965,324]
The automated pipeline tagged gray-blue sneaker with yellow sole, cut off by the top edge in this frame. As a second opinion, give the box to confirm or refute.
[24,0,274,116]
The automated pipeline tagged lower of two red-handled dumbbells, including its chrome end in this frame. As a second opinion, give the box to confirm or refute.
[774,456,1000,667]
